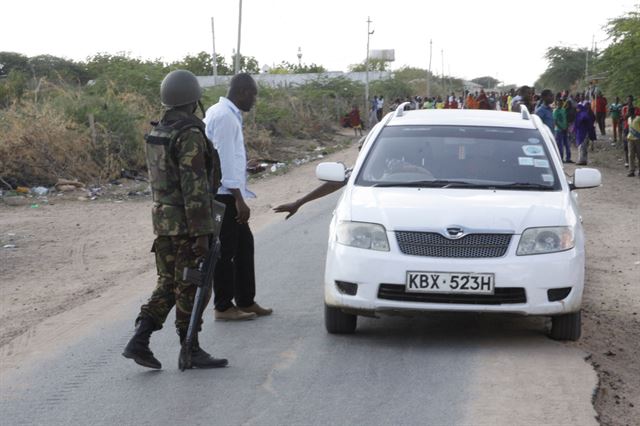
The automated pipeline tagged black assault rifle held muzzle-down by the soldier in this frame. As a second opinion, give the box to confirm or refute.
[178,201,225,371]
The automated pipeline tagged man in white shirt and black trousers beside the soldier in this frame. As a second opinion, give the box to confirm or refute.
[204,73,272,321]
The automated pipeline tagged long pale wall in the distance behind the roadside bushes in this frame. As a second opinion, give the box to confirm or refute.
[198,71,393,87]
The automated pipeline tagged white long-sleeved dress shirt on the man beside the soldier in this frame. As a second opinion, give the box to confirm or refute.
[204,96,256,198]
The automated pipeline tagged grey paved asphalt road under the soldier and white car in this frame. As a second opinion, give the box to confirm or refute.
[0,196,597,426]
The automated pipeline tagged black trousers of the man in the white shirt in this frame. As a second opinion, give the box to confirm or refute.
[213,195,256,311]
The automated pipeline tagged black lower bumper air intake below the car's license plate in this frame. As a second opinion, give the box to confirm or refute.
[378,284,527,305]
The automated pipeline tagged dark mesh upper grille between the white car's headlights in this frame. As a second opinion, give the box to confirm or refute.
[396,231,511,258]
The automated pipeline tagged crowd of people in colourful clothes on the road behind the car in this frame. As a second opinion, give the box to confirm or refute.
[342,86,640,177]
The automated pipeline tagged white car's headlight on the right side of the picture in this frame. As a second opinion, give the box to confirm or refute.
[516,226,575,256]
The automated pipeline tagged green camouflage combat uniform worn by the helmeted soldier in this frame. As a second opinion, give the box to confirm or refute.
[139,110,220,330]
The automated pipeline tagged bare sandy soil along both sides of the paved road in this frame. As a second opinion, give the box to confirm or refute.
[0,133,640,425]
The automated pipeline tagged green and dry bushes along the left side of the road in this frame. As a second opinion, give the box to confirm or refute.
[0,52,444,189]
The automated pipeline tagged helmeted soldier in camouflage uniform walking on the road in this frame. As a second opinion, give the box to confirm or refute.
[123,70,227,368]
